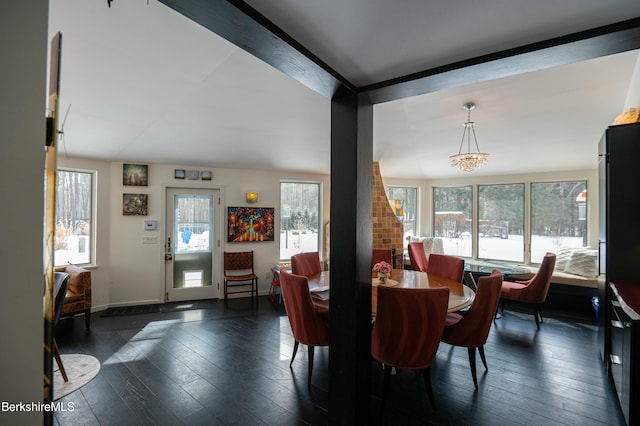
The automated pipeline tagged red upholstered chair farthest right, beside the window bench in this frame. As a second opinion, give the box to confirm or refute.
[500,252,556,330]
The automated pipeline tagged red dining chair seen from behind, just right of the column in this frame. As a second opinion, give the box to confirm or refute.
[372,286,449,410]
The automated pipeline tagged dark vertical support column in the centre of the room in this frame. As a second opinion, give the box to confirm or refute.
[329,95,373,425]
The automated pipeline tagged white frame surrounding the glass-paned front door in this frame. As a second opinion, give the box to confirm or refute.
[159,182,226,303]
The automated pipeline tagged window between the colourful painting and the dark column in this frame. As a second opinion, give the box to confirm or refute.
[280,182,321,260]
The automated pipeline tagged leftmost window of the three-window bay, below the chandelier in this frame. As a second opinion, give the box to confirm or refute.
[433,186,473,257]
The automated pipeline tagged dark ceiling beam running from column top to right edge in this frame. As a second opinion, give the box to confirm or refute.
[359,18,640,104]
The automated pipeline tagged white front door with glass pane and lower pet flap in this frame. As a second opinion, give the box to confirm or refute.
[165,188,220,302]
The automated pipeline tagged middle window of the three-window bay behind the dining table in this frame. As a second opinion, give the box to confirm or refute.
[478,183,524,262]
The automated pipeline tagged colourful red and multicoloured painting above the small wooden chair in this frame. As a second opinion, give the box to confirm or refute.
[227,207,275,243]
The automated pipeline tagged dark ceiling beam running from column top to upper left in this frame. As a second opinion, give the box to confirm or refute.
[158,0,357,99]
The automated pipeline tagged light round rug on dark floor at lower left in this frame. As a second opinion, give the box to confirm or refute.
[53,354,100,401]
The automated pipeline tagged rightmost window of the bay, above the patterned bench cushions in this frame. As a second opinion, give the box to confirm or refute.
[531,181,587,263]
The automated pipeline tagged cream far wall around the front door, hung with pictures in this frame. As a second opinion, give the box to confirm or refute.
[58,158,331,311]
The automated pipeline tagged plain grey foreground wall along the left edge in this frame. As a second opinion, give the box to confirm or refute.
[0,0,49,425]
